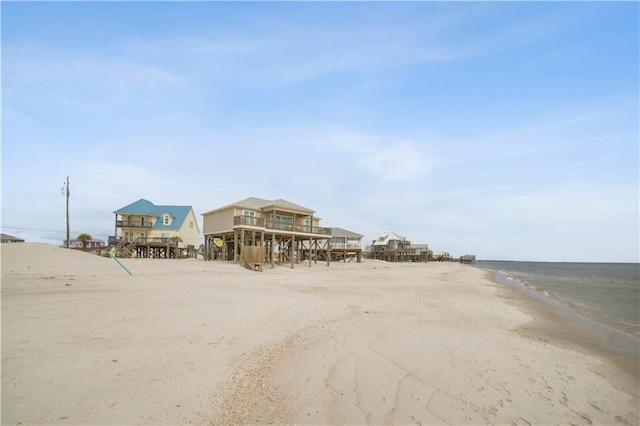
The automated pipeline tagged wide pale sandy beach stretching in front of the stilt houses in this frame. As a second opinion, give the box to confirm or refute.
[0,243,639,425]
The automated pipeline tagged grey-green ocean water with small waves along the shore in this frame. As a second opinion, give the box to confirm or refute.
[476,261,640,348]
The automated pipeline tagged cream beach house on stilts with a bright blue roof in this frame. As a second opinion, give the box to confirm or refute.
[109,198,200,258]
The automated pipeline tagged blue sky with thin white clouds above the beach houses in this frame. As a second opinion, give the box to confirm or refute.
[1,2,640,262]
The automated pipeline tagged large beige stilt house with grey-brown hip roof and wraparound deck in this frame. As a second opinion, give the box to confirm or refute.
[202,197,332,268]
